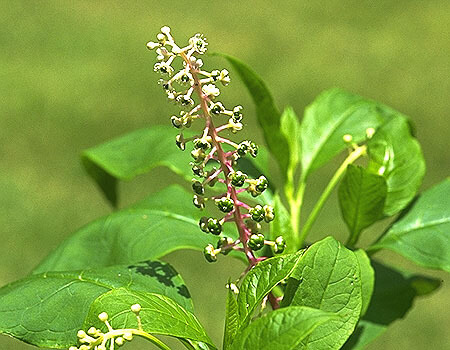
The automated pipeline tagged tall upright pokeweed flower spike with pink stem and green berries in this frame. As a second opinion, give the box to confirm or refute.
[147,27,285,265]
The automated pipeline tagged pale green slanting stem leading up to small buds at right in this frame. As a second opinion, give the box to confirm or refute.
[299,145,367,247]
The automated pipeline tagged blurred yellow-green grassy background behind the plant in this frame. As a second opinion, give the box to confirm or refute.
[0,0,450,350]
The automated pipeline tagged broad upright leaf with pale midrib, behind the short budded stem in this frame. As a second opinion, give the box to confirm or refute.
[300,89,391,179]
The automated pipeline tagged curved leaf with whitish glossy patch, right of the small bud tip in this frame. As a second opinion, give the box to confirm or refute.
[367,115,425,216]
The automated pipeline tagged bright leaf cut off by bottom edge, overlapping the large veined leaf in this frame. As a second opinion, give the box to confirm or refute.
[231,306,336,350]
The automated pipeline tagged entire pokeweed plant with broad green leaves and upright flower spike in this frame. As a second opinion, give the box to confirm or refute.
[0,27,450,350]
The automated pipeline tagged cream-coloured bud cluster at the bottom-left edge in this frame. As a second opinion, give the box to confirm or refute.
[69,304,142,350]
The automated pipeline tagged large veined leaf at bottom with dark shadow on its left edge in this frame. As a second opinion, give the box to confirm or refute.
[281,237,363,350]
